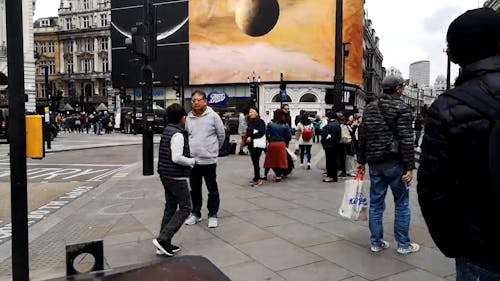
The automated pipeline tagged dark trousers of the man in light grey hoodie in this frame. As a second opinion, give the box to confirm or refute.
[190,164,220,218]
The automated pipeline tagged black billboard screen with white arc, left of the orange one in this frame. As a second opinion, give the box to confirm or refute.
[111,0,189,88]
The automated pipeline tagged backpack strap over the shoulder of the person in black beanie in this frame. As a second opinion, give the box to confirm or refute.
[444,80,500,122]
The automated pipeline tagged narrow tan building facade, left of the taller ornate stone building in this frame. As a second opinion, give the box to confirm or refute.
[33,17,61,113]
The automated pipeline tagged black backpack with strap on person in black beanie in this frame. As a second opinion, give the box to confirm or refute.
[445,80,500,197]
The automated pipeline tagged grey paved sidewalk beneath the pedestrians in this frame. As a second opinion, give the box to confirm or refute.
[0,142,455,281]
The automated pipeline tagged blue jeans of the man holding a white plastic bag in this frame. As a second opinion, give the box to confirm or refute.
[369,164,410,249]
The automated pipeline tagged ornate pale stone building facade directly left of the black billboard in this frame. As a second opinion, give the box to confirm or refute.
[57,0,113,112]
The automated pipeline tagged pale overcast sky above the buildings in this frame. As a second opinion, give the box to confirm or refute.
[35,0,485,84]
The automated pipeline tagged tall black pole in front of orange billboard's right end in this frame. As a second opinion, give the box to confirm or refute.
[333,0,344,110]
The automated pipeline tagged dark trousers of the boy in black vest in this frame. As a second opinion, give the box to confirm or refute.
[158,177,191,244]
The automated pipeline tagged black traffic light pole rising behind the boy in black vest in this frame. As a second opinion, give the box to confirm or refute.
[142,0,156,176]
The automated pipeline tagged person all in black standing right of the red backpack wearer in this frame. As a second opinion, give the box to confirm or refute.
[321,111,341,182]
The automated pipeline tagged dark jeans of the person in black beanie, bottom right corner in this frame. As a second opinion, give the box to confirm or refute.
[455,258,500,281]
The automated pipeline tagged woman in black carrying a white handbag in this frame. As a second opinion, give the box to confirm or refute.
[246,107,266,186]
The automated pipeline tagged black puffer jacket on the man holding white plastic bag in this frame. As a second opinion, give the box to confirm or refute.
[358,94,415,171]
